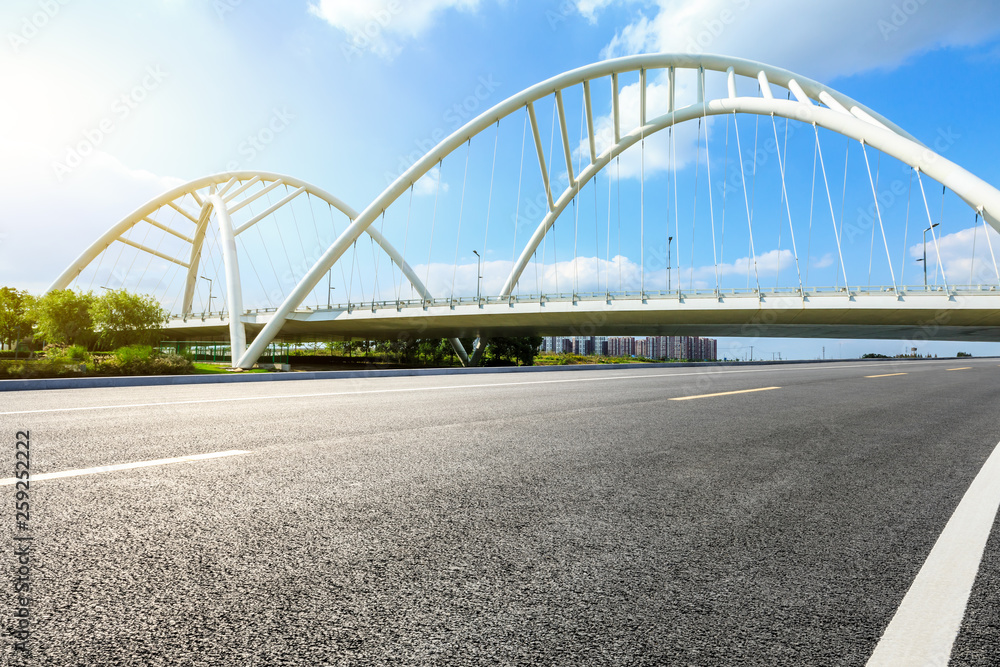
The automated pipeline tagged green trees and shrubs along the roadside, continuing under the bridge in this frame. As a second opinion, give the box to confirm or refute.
[0,287,542,379]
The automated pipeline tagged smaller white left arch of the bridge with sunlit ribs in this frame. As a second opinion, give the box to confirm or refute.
[47,171,469,365]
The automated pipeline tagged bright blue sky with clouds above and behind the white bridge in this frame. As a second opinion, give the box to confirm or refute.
[0,0,1000,357]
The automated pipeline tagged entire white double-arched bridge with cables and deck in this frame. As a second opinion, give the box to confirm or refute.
[50,54,1000,368]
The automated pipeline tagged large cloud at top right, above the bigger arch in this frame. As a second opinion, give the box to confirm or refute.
[576,0,1000,81]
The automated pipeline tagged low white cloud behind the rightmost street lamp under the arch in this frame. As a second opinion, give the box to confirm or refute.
[906,224,1000,285]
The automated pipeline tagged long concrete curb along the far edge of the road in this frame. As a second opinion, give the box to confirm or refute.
[0,357,952,392]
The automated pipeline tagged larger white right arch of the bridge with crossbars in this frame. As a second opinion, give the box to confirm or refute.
[232,54,1000,368]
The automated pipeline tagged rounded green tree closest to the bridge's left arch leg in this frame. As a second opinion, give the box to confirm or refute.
[90,290,168,349]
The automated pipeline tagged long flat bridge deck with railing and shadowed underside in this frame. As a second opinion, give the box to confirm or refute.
[167,292,1000,341]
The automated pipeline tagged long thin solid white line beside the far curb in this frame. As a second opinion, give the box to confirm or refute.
[0,363,952,417]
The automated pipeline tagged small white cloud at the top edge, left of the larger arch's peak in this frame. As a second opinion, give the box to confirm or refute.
[309,0,480,59]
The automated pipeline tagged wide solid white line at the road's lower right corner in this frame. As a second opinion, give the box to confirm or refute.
[868,444,1000,667]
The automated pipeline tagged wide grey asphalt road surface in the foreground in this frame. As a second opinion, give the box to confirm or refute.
[0,360,1000,665]
